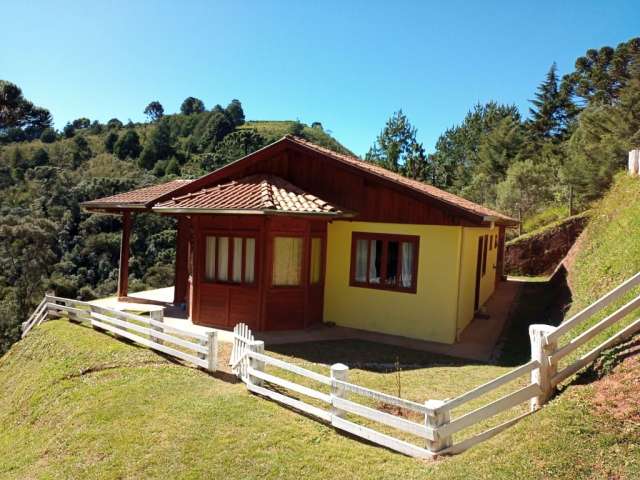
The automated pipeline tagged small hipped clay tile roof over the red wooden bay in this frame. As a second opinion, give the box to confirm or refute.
[153,174,344,215]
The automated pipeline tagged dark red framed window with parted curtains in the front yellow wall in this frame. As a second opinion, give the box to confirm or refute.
[350,232,418,292]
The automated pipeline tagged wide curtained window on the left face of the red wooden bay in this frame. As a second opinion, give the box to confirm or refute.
[204,235,256,284]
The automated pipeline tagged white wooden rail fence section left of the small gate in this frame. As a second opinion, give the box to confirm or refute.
[22,295,218,372]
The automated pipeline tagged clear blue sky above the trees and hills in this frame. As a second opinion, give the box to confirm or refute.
[0,0,640,154]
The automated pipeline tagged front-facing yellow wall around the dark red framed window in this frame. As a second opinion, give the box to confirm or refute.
[324,221,462,343]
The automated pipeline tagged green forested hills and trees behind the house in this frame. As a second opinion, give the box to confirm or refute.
[0,38,640,354]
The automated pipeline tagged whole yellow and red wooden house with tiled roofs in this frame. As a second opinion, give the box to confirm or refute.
[83,136,517,343]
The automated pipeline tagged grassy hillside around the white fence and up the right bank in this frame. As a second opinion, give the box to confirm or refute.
[0,175,640,480]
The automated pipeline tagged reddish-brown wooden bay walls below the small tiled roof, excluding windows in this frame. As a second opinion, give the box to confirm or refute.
[185,215,326,331]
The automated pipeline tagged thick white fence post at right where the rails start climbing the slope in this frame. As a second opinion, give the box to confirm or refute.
[529,324,558,411]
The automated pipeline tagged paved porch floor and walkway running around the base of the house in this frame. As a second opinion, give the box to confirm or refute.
[91,281,520,362]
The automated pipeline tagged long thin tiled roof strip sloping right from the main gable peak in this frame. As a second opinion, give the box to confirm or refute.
[285,135,518,224]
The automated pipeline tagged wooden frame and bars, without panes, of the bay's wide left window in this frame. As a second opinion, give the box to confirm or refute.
[199,230,259,287]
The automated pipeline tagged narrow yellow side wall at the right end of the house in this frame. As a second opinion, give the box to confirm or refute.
[457,227,498,334]
